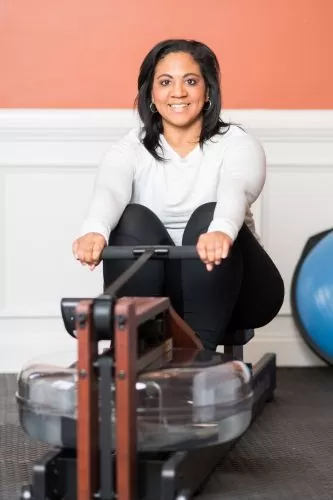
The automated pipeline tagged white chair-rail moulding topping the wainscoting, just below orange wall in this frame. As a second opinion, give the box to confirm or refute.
[0,108,333,142]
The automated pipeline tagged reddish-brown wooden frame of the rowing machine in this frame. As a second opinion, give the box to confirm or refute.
[76,297,202,500]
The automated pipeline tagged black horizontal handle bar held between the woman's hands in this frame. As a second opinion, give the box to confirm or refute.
[102,245,199,260]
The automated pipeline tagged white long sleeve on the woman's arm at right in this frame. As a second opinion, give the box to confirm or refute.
[208,134,266,241]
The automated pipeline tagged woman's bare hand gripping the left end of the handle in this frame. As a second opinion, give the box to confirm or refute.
[72,233,106,270]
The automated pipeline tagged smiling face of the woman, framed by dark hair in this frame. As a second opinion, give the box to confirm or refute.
[152,52,208,127]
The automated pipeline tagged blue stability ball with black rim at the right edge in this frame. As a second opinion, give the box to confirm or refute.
[292,230,333,364]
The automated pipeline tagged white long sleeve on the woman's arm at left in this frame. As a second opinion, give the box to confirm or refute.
[81,137,135,242]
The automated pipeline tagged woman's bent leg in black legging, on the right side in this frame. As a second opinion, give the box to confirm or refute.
[178,203,284,350]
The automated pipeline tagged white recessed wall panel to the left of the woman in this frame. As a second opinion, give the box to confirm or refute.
[0,167,101,317]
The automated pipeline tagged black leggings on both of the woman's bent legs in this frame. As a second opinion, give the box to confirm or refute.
[103,203,284,350]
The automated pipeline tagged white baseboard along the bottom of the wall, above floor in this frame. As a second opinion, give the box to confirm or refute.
[0,316,324,373]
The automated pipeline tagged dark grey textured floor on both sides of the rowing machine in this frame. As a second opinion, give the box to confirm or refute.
[0,368,333,500]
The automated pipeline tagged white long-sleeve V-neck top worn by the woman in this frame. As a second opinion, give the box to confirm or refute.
[81,125,266,245]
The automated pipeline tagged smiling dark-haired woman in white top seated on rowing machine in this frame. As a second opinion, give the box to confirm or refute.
[73,40,284,350]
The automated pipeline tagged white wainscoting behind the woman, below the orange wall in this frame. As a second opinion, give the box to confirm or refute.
[0,110,333,372]
